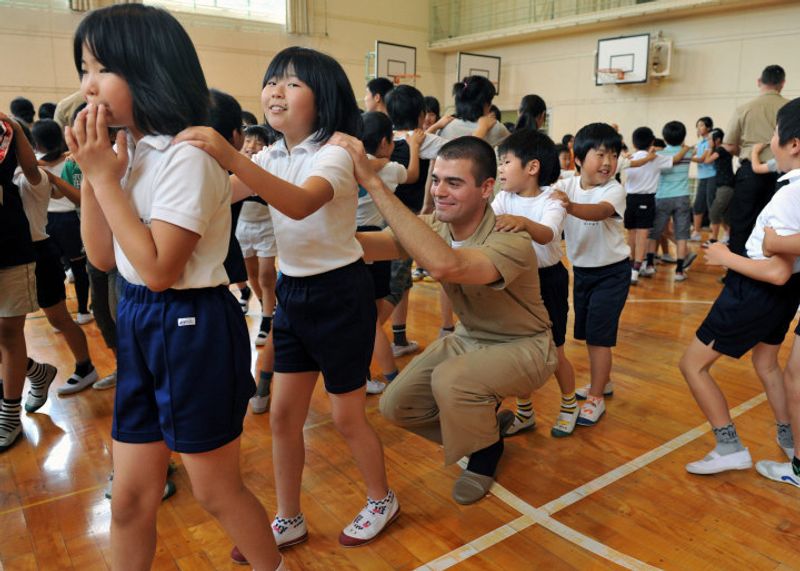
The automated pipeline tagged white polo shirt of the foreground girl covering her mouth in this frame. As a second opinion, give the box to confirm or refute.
[114,135,231,289]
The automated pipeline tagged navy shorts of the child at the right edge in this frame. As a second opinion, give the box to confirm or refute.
[697,271,800,359]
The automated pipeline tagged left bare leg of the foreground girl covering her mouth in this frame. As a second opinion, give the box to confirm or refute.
[111,440,170,571]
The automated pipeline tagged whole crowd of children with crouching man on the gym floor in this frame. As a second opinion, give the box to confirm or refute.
[0,5,800,570]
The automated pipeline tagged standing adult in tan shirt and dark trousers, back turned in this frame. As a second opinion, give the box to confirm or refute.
[722,65,789,254]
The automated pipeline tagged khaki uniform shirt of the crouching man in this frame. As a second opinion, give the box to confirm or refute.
[395,207,551,343]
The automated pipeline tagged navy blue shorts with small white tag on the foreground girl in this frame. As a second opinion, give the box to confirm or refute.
[111,276,255,453]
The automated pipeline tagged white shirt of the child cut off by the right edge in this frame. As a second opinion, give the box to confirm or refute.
[744,169,800,274]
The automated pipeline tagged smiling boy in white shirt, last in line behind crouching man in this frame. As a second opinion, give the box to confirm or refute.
[554,123,631,426]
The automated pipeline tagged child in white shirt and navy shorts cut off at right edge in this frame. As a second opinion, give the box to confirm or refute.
[680,99,800,478]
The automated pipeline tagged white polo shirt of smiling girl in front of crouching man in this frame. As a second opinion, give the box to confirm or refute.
[253,135,364,277]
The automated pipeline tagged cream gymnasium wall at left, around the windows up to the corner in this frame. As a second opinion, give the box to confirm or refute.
[0,0,445,120]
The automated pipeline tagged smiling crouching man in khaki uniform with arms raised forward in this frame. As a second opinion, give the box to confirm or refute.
[331,135,557,510]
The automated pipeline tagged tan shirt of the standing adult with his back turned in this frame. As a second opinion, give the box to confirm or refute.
[723,91,789,162]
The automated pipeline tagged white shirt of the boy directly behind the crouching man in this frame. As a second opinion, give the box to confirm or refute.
[492,187,567,269]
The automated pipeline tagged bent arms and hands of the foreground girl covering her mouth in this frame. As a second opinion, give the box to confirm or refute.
[66,105,197,291]
